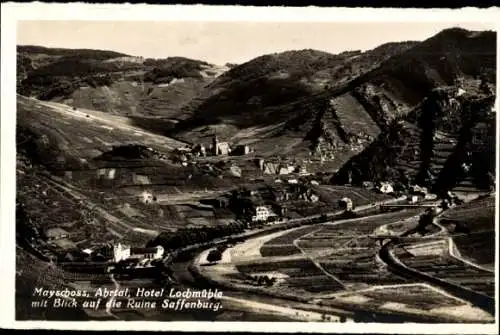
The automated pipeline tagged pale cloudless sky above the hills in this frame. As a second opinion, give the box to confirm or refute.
[17,20,491,65]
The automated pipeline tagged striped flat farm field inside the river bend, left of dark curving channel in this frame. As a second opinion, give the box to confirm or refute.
[202,209,422,298]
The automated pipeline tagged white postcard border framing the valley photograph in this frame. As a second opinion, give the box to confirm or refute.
[0,3,500,334]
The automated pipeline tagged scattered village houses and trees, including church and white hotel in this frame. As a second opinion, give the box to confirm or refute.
[17,138,458,284]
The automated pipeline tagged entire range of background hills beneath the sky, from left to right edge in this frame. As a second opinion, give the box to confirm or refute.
[18,28,496,172]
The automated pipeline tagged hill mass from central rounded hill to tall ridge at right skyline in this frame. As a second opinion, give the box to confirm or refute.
[173,29,496,166]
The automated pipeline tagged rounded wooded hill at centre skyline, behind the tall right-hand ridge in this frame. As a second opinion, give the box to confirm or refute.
[178,42,416,123]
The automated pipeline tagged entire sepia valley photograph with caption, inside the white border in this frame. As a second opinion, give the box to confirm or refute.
[2,2,498,330]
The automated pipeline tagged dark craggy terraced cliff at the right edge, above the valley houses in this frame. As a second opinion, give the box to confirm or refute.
[332,86,495,192]
